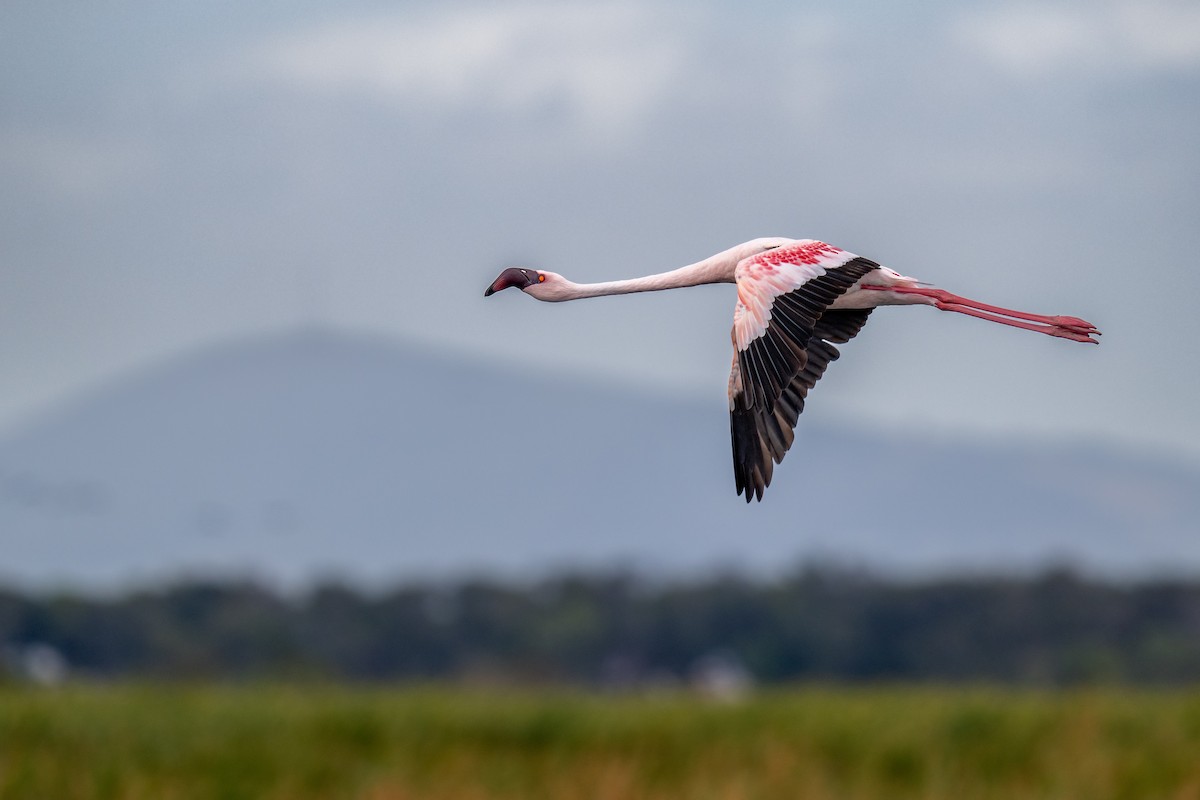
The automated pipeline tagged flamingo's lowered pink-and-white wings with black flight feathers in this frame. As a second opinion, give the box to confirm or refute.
[730,240,880,503]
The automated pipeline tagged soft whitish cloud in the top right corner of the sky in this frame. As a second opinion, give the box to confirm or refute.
[949,0,1200,77]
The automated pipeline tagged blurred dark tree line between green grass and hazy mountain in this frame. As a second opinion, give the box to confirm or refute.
[0,569,1200,686]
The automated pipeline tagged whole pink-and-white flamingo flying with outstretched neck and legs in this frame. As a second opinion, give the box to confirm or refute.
[484,237,1100,503]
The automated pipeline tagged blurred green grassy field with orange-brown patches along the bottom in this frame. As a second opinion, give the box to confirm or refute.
[0,685,1200,800]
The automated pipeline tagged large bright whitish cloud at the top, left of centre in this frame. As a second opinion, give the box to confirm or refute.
[243,4,686,133]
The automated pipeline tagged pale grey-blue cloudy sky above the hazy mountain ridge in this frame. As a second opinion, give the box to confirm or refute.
[0,0,1200,459]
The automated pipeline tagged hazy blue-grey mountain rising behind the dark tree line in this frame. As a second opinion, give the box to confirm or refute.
[0,330,1200,587]
